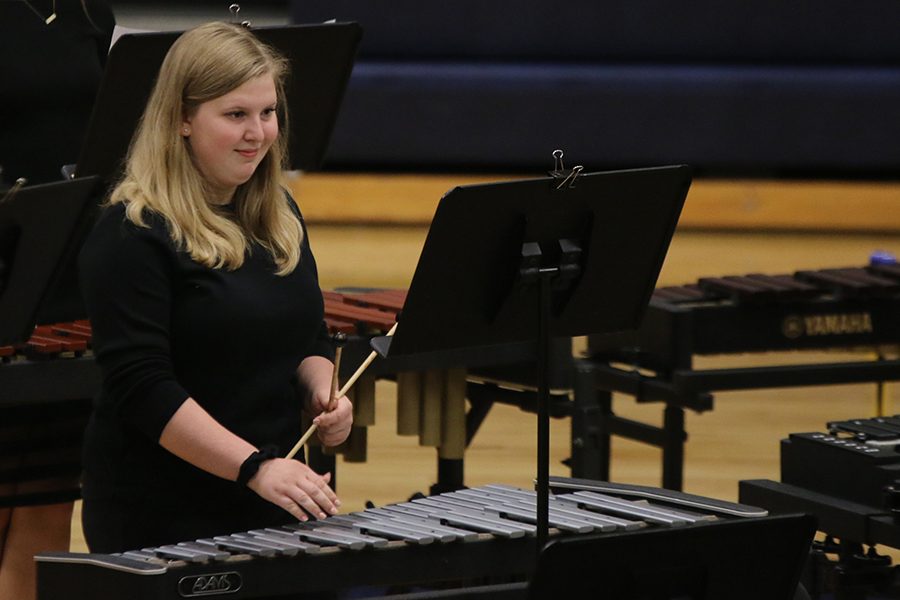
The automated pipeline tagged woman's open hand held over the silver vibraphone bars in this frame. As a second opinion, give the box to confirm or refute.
[247,458,341,521]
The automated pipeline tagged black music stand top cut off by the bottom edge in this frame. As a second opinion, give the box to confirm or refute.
[528,514,816,600]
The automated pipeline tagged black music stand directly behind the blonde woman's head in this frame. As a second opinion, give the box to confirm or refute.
[75,23,362,183]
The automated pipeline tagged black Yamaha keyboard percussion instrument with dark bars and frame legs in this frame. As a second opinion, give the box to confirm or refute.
[573,263,900,489]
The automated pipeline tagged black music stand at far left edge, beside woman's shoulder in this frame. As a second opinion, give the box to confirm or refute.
[0,177,102,346]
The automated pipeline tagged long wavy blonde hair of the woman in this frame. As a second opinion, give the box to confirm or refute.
[109,23,303,275]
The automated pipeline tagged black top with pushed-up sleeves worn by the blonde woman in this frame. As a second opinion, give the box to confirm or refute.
[80,199,332,541]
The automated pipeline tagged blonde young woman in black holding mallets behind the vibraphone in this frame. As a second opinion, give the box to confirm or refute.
[80,23,352,552]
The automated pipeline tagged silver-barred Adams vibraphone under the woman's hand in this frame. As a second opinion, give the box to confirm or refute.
[36,480,765,600]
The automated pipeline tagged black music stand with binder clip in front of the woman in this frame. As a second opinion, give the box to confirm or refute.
[372,166,690,548]
